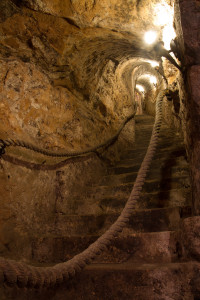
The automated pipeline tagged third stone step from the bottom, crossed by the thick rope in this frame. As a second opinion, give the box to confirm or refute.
[54,206,189,236]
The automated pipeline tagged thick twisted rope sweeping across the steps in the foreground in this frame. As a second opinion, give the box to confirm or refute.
[0,91,165,288]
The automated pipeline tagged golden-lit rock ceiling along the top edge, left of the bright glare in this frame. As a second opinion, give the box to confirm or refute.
[12,0,172,32]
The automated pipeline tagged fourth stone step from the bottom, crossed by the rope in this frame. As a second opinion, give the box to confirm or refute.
[88,184,191,212]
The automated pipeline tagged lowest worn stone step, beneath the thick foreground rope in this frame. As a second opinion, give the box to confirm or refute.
[0,262,196,300]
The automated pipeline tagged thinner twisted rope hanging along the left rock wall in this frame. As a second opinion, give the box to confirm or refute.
[0,114,135,157]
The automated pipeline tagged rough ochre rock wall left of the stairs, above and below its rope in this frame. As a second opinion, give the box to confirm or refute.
[0,1,141,259]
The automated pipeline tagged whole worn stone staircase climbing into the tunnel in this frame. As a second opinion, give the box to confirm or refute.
[3,115,199,300]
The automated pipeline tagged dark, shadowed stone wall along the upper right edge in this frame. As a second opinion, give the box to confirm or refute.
[175,0,200,215]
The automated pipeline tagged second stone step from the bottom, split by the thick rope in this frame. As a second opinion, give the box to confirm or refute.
[31,231,180,263]
